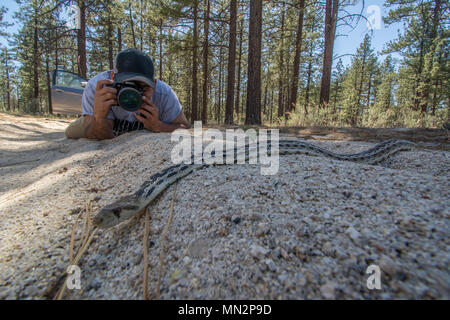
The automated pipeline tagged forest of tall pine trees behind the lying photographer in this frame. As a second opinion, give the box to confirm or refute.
[0,0,450,128]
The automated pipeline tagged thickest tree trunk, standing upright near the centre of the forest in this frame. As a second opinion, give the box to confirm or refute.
[245,0,262,124]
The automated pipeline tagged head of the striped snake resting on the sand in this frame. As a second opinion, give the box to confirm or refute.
[92,196,141,228]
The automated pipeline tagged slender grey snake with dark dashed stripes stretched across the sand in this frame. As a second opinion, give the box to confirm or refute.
[93,139,416,229]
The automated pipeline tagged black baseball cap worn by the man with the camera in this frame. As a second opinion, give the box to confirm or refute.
[114,48,156,88]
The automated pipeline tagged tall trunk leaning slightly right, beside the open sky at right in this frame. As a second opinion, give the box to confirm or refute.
[319,0,339,108]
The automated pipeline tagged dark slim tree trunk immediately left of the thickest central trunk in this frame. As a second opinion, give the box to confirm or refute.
[225,0,237,124]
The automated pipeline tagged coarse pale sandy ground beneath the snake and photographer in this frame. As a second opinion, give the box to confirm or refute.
[0,114,450,299]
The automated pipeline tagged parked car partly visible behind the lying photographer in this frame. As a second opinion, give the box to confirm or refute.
[52,70,87,115]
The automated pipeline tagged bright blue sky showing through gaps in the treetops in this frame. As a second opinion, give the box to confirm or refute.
[0,0,403,65]
